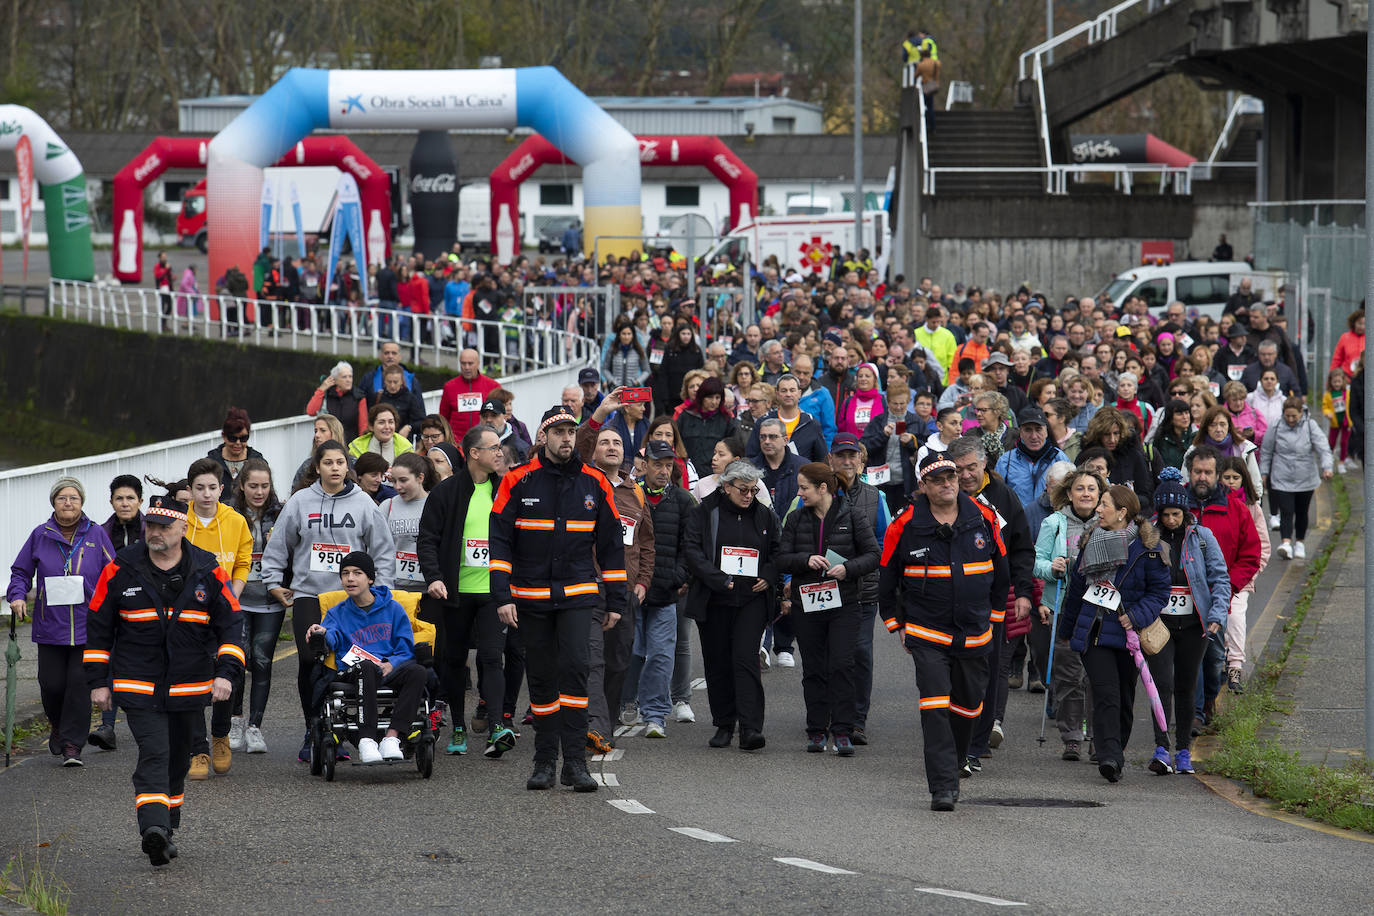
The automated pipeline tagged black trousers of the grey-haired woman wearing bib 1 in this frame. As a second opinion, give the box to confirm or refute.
[697,593,787,732]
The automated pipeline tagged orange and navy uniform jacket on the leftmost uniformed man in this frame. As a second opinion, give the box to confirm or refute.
[82,538,243,711]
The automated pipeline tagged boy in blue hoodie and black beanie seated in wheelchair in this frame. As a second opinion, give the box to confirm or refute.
[306,551,430,764]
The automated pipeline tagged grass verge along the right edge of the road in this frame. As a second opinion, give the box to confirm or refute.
[1206,477,1374,834]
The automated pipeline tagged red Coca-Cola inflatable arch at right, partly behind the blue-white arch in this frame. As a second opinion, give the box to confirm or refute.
[491,135,758,256]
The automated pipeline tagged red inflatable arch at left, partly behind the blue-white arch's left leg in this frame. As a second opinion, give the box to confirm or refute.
[114,135,392,283]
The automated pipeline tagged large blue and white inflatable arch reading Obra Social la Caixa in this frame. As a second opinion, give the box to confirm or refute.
[207,67,640,284]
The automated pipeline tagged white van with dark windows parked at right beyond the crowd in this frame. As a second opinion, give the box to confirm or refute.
[1098,261,1286,320]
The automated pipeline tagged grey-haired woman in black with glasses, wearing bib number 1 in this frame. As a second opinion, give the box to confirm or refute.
[683,461,782,751]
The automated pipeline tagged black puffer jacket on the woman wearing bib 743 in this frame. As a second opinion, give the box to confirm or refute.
[778,492,878,612]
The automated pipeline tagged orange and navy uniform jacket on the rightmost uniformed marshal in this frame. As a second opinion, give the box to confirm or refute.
[878,492,1011,655]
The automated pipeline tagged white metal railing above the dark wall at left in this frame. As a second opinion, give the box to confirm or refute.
[48,279,596,375]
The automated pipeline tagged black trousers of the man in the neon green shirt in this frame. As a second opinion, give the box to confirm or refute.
[438,595,507,724]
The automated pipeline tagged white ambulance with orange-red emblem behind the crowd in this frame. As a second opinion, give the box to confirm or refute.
[702,210,892,275]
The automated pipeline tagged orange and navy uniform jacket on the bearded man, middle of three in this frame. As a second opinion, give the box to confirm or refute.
[488,449,625,614]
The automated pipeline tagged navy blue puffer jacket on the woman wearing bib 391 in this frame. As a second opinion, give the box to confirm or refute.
[1063,529,1169,652]
